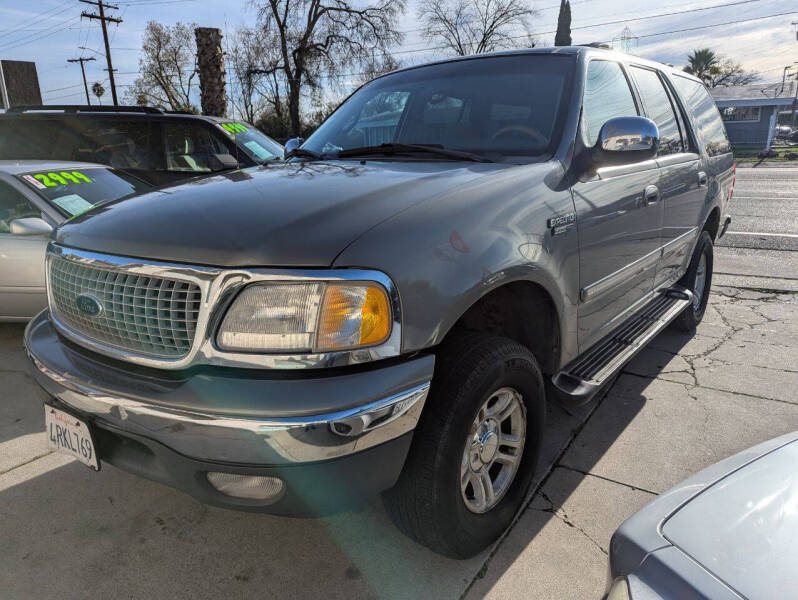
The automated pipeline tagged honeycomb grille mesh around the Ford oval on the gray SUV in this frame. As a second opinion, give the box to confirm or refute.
[48,256,202,358]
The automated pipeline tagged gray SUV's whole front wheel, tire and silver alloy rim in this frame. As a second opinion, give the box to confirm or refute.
[385,333,545,558]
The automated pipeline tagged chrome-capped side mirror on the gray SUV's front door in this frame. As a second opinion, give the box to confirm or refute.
[591,117,659,167]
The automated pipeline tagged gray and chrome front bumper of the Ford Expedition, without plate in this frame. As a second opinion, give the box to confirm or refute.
[25,311,435,514]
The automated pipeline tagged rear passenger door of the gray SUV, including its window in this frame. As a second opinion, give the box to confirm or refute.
[629,65,707,287]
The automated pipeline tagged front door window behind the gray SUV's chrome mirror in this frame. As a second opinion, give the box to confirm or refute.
[582,60,637,146]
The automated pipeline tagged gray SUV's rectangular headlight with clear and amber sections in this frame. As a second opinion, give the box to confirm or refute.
[216,282,392,353]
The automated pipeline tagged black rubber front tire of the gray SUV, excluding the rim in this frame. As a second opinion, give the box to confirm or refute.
[384,333,545,558]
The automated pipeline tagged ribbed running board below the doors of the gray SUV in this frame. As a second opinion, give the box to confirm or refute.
[552,286,693,406]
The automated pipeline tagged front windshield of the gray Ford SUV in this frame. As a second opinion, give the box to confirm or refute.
[302,54,573,160]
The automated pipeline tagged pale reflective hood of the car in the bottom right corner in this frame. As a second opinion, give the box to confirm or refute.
[662,442,798,599]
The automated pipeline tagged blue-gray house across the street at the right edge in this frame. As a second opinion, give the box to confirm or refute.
[709,81,796,148]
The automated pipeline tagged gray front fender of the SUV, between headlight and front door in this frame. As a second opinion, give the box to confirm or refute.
[335,163,579,362]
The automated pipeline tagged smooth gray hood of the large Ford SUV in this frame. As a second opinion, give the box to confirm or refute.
[56,161,510,267]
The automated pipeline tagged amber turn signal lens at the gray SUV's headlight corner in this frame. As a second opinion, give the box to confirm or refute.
[317,283,391,352]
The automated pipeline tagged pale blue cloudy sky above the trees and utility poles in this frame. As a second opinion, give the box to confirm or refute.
[0,0,798,103]
